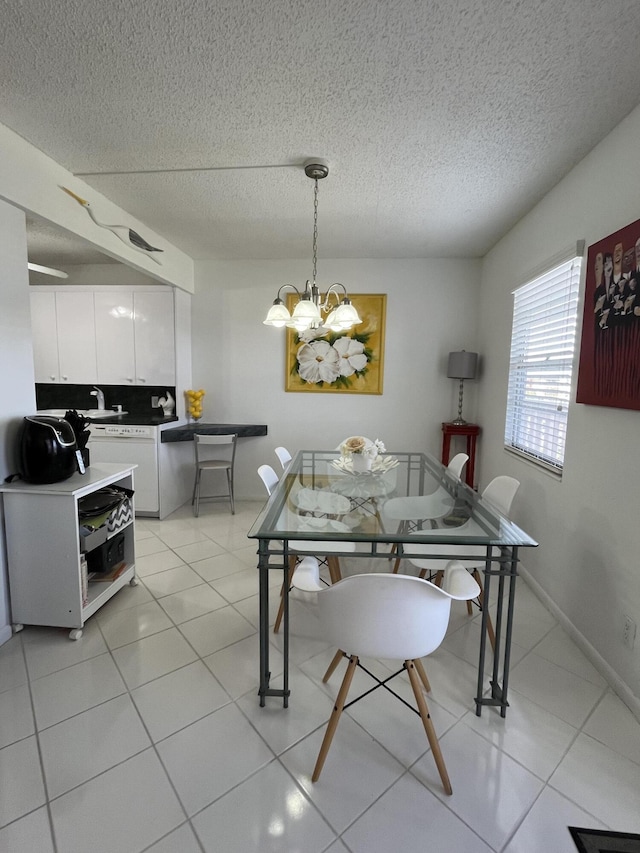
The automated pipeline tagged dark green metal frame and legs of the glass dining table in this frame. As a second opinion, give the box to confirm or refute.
[248,451,537,717]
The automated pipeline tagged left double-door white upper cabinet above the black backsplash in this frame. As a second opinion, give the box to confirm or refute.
[29,290,97,385]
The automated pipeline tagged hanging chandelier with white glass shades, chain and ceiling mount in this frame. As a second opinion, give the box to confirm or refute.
[263,157,362,335]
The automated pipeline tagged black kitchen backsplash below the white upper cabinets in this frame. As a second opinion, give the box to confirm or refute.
[36,382,183,416]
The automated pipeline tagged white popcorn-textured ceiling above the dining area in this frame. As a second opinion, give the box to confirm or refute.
[0,0,640,263]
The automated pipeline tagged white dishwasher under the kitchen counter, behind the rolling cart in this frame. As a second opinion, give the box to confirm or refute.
[88,423,160,515]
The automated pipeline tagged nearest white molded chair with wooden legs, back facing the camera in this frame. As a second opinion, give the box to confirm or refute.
[294,557,479,794]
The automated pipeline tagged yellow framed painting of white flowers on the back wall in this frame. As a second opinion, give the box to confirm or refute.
[285,293,387,394]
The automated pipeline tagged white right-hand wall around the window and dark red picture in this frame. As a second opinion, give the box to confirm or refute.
[479,103,640,707]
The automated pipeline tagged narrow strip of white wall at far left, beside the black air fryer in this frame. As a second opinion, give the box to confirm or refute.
[0,201,36,644]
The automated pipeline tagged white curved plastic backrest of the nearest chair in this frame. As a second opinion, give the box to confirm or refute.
[318,564,480,660]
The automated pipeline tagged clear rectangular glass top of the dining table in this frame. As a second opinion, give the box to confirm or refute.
[248,450,538,552]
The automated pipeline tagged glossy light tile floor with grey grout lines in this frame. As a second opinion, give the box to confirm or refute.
[0,502,640,853]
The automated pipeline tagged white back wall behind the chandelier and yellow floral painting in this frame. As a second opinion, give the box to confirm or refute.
[192,259,480,499]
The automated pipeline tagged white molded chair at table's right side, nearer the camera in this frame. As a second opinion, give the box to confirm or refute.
[409,475,520,649]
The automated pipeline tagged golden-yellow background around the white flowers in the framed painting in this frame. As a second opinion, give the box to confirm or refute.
[285,293,387,394]
